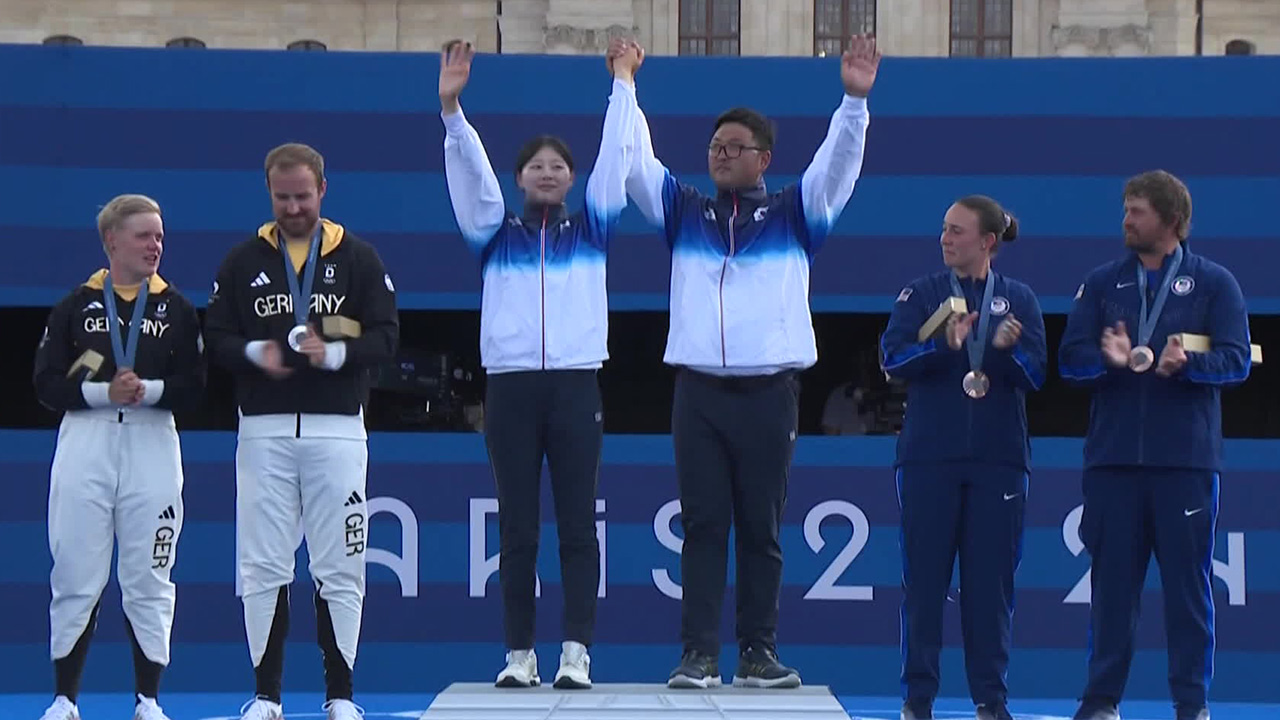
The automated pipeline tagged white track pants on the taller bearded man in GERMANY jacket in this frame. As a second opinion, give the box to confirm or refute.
[236,437,369,667]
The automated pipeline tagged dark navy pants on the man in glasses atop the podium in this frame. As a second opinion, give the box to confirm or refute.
[671,369,800,657]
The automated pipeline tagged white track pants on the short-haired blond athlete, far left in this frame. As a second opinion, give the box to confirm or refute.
[49,409,183,665]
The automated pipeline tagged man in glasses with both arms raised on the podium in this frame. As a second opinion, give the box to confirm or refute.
[627,37,879,688]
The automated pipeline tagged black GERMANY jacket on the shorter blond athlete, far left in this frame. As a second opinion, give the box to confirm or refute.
[33,269,205,413]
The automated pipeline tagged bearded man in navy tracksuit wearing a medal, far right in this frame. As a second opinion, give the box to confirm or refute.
[1059,170,1251,720]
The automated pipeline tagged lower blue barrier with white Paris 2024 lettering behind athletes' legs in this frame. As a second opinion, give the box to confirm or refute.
[0,430,1280,702]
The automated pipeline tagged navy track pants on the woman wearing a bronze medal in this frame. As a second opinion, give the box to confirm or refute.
[897,462,1028,705]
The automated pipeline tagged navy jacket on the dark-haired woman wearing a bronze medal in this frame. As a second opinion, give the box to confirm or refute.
[881,270,1048,470]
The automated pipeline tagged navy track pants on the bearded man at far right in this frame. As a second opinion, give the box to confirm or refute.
[1080,466,1219,708]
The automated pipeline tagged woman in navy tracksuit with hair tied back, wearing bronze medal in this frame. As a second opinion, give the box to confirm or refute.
[881,195,1047,720]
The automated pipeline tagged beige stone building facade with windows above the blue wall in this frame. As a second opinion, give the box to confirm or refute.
[0,0,1280,56]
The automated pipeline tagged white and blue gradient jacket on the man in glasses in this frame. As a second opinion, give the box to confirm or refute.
[627,95,870,375]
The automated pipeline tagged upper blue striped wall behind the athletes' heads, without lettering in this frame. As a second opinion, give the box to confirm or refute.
[0,46,1280,313]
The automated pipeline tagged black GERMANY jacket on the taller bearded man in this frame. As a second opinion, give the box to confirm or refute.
[205,220,399,416]
